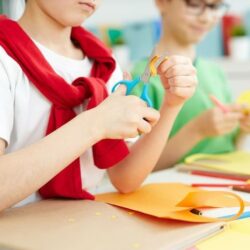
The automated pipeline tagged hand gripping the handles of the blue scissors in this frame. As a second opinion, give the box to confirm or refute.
[96,85,160,139]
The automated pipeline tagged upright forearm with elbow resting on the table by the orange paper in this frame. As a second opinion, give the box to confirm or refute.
[108,101,181,193]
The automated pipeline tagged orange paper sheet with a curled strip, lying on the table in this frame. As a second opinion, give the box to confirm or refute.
[96,183,244,222]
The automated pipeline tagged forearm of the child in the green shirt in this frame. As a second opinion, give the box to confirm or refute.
[155,120,202,170]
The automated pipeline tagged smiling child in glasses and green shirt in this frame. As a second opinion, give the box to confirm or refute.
[133,0,250,169]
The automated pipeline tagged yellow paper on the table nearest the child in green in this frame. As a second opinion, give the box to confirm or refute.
[185,151,250,175]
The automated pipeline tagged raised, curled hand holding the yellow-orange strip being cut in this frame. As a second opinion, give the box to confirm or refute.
[157,56,198,106]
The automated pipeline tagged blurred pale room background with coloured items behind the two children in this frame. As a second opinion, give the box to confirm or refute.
[0,0,250,97]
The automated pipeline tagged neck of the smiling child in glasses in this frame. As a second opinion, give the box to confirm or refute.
[157,30,196,60]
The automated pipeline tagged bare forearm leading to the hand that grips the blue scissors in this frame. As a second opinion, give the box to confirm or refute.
[0,111,100,211]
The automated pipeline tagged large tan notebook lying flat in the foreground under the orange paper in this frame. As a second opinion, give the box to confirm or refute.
[0,200,225,250]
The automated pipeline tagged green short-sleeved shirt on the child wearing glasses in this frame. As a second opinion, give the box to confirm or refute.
[133,59,237,161]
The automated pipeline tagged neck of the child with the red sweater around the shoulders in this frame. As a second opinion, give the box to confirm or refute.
[18,1,84,59]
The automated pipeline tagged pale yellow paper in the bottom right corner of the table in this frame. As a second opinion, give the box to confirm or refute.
[197,219,250,250]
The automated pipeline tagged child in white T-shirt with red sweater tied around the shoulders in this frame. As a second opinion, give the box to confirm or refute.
[0,0,197,211]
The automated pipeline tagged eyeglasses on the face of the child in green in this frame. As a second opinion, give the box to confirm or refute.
[184,0,230,17]
